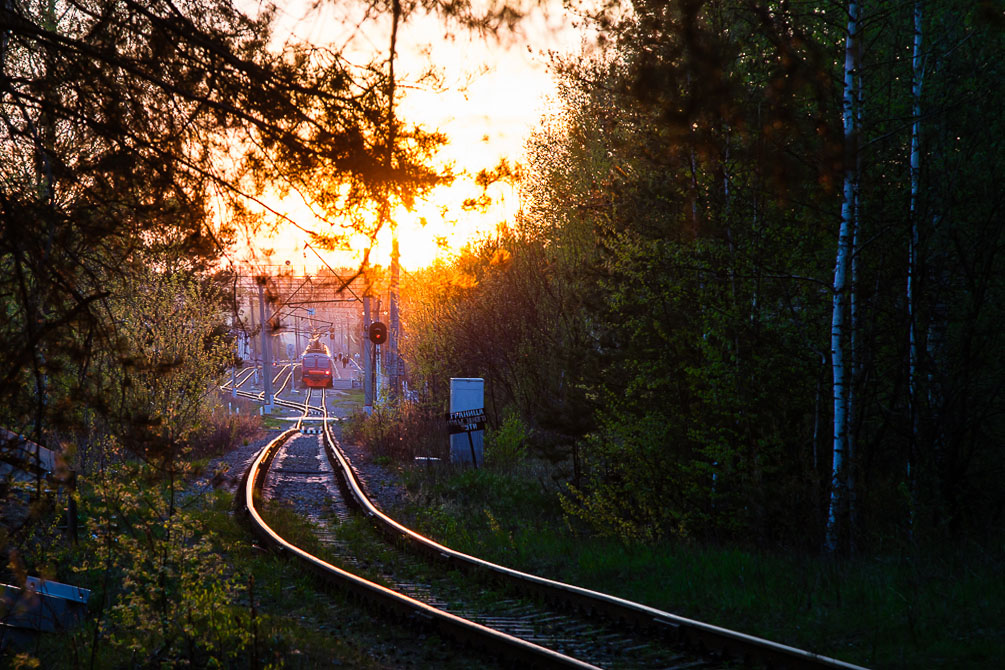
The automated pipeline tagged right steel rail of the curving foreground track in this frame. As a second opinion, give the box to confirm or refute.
[325,423,866,670]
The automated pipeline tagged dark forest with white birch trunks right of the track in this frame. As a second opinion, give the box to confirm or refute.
[406,1,1005,553]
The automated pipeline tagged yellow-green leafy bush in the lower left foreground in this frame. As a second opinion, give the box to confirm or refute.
[72,461,251,667]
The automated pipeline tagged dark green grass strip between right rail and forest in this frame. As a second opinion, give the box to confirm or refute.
[402,468,1005,668]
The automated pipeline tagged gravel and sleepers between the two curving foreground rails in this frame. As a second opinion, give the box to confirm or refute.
[255,419,734,669]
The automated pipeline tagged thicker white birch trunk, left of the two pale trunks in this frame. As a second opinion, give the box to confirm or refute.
[824,0,860,552]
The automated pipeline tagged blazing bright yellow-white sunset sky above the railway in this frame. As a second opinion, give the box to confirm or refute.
[230,0,581,271]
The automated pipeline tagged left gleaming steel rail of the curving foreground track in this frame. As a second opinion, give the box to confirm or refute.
[237,429,599,670]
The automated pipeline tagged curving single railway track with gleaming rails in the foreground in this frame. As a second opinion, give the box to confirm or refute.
[231,391,858,670]
